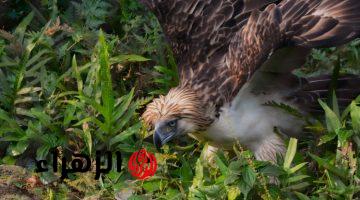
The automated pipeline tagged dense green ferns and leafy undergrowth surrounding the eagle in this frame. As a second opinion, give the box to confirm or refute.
[0,0,360,200]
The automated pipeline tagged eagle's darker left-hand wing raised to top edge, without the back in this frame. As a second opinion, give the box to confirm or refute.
[140,0,275,83]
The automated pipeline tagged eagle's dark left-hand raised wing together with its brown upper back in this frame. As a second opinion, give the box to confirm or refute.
[140,0,276,108]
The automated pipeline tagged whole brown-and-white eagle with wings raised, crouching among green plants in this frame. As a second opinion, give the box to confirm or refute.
[140,0,360,162]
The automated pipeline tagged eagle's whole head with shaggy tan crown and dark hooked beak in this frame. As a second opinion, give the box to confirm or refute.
[142,87,212,149]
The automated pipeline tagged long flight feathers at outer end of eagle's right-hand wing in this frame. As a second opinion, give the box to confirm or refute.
[279,0,360,48]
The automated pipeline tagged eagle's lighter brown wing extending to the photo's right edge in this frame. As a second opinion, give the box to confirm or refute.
[226,0,360,104]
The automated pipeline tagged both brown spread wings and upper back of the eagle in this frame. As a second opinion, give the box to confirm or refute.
[140,0,360,106]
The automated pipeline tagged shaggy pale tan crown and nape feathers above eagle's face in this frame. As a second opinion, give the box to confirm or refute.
[142,87,212,129]
